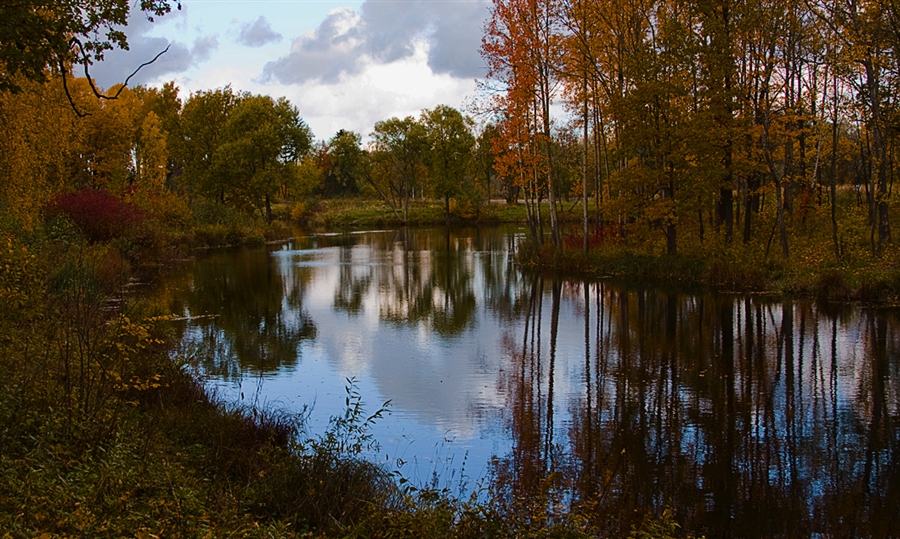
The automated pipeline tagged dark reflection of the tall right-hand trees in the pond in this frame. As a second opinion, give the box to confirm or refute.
[497,278,900,537]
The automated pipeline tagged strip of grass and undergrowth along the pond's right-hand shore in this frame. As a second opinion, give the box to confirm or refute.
[519,196,900,305]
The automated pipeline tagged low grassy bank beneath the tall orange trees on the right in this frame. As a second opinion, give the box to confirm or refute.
[519,217,900,305]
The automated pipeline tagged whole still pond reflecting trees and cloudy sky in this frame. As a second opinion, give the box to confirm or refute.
[163,228,900,537]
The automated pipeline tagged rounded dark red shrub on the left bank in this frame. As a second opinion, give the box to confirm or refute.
[45,189,143,241]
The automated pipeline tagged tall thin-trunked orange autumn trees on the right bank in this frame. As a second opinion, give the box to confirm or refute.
[482,0,900,259]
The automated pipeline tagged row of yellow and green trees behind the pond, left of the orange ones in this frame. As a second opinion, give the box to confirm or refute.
[0,74,506,228]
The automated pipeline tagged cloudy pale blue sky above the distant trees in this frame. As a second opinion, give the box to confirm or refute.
[91,0,490,140]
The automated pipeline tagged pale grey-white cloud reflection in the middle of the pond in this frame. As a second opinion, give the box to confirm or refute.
[264,231,528,439]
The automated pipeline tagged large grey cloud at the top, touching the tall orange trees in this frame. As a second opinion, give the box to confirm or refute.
[262,0,489,84]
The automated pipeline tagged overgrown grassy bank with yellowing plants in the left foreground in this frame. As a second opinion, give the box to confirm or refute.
[0,237,396,537]
